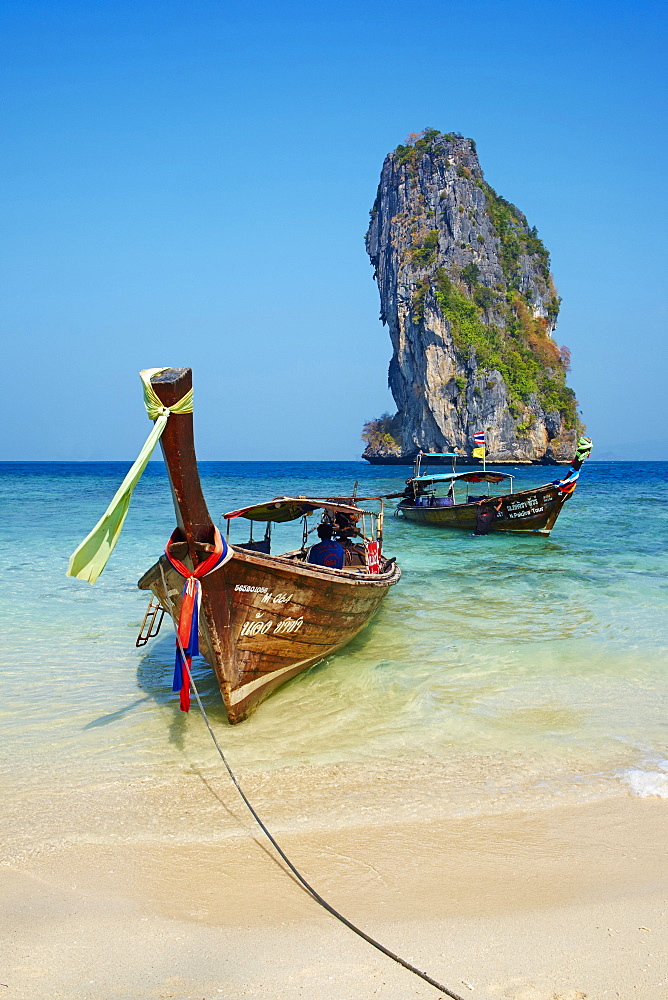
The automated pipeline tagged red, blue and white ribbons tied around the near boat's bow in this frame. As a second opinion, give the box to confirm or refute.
[165,525,234,712]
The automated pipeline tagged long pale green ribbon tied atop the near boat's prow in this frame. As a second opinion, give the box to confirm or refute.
[67,368,193,583]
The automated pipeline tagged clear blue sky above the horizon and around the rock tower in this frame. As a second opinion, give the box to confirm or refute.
[0,0,668,460]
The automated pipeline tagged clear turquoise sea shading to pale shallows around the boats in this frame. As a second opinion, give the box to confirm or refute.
[0,461,668,855]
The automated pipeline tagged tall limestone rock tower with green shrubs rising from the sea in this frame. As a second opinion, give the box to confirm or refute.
[363,129,581,462]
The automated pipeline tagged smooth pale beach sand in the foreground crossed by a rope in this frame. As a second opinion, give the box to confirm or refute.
[0,789,668,1000]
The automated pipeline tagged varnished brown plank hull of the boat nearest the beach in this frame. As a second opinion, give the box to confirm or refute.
[139,548,401,724]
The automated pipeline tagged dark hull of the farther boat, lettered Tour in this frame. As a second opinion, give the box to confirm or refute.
[397,484,568,535]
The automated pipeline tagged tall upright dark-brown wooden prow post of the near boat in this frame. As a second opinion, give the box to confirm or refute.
[151,368,214,566]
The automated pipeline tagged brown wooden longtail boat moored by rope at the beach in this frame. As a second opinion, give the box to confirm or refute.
[134,368,401,724]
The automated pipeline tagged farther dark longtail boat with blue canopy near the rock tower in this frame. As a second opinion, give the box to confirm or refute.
[391,438,592,535]
